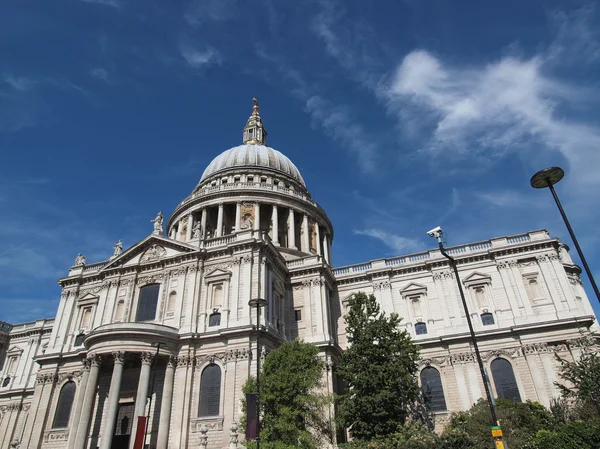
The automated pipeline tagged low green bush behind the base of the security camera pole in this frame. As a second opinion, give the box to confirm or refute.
[444,399,556,449]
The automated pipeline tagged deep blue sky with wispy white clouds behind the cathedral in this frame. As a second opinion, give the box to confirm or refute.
[0,0,600,322]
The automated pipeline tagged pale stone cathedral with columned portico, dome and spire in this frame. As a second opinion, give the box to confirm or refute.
[0,102,597,449]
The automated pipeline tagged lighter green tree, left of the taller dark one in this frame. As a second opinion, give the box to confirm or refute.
[242,341,332,449]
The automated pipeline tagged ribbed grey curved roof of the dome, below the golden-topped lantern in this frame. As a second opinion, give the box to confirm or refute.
[200,144,306,187]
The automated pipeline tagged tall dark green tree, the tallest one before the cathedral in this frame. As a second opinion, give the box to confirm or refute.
[338,292,419,441]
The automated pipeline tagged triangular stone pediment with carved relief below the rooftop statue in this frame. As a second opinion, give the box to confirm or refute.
[102,235,198,271]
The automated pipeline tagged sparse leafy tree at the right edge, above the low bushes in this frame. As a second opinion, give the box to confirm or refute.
[555,351,600,414]
